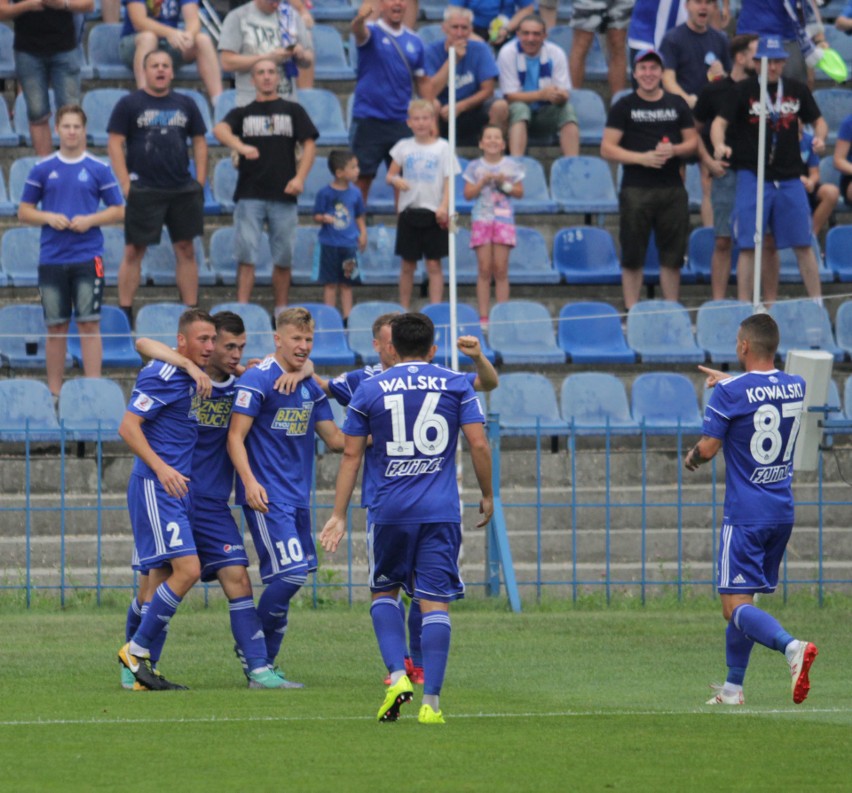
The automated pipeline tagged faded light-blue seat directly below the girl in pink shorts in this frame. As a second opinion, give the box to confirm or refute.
[488,300,565,364]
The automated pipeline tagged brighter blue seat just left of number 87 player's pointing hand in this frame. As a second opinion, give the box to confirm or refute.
[631,372,703,435]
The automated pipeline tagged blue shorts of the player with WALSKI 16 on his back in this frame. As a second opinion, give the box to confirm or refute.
[367,523,464,603]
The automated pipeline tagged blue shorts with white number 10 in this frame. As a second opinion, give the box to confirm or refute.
[243,503,317,582]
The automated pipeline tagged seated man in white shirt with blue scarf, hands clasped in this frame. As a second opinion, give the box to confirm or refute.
[497,14,580,157]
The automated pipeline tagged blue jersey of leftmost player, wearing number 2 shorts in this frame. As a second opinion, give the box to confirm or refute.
[127,360,198,479]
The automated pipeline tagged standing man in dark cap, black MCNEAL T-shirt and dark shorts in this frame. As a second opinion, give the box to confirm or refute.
[601,49,698,309]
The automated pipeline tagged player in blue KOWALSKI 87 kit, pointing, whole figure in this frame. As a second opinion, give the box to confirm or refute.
[685,314,817,705]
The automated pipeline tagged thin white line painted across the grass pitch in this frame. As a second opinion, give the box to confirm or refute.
[0,708,852,727]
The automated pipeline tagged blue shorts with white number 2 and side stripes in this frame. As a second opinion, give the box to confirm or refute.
[127,474,196,572]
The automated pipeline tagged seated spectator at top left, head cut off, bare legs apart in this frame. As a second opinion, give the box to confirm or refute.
[118,0,222,104]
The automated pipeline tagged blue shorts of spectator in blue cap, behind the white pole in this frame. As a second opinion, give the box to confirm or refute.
[732,170,811,250]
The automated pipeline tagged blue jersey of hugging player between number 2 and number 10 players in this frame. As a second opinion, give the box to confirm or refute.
[192,375,237,501]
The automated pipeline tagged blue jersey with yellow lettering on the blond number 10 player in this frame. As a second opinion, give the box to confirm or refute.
[233,355,334,507]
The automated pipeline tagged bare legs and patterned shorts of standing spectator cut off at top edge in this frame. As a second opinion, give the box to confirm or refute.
[570,0,636,96]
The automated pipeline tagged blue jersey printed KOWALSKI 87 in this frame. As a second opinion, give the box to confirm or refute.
[703,369,805,525]
